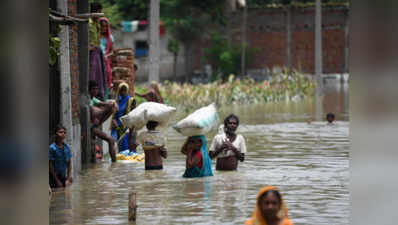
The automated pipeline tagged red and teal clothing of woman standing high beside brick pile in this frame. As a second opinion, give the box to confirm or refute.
[99,17,114,89]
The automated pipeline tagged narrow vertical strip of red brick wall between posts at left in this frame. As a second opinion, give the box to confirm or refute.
[68,0,80,121]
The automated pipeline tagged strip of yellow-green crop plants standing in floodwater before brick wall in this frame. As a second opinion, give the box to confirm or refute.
[136,71,314,108]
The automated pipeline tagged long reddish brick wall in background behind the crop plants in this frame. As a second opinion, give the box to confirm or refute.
[192,7,348,73]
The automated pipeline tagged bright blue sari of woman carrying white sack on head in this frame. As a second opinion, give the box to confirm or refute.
[183,135,213,178]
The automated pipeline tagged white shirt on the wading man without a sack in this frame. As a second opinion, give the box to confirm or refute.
[210,133,246,158]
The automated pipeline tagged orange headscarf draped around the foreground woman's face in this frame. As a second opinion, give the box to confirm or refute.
[245,186,291,225]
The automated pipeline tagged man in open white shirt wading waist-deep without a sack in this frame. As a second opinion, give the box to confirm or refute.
[209,114,246,170]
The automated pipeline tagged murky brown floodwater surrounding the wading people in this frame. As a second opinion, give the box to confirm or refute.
[50,78,350,225]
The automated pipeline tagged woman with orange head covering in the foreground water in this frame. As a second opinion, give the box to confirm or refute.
[245,186,293,225]
